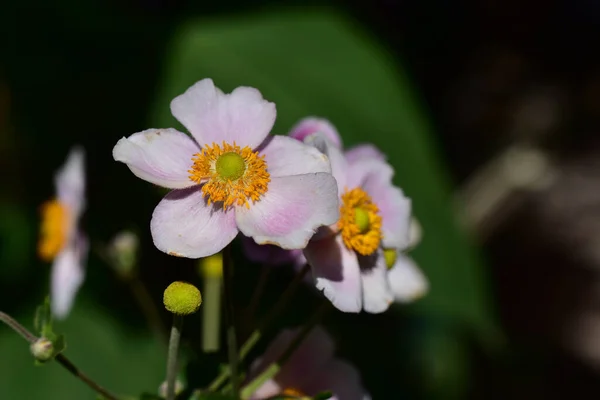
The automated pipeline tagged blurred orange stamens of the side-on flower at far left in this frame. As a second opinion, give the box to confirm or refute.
[38,199,69,261]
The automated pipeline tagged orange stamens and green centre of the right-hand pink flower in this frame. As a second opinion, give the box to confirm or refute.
[338,188,382,256]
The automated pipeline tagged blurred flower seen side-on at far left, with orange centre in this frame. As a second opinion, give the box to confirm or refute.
[38,147,88,318]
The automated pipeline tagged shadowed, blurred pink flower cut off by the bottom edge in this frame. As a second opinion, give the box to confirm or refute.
[248,326,370,400]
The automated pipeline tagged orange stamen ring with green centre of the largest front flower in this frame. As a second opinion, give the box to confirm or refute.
[188,142,271,210]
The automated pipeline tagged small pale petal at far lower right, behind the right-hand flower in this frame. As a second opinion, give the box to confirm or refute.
[388,252,429,303]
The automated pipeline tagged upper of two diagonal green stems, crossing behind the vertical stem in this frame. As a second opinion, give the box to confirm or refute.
[208,264,310,392]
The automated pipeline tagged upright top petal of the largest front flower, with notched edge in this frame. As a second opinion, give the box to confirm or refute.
[171,79,277,148]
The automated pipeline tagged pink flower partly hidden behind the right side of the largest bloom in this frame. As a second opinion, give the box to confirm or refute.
[290,118,411,313]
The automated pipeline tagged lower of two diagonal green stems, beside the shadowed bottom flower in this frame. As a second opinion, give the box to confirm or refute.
[241,301,331,399]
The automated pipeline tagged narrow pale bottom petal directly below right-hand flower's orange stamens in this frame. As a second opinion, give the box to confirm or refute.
[359,252,394,314]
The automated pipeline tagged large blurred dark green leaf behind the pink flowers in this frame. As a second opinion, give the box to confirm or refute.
[150,10,489,325]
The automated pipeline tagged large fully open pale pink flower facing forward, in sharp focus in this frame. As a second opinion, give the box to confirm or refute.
[113,79,338,258]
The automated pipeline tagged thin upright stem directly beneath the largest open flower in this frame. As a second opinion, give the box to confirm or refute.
[223,246,239,399]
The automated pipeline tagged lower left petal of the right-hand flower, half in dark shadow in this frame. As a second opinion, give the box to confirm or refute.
[304,235,362,313]
